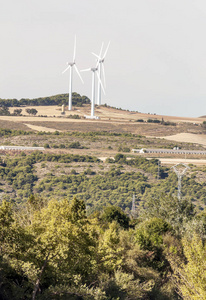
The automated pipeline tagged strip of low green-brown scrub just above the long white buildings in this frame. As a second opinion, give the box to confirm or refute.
[0,128,204,152]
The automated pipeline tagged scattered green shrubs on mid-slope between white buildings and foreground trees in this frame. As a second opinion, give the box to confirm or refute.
[0,152,206,213]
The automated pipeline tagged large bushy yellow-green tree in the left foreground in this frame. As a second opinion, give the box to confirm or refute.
[0,196,95,300]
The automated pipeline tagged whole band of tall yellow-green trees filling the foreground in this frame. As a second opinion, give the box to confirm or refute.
[0,195,206,300]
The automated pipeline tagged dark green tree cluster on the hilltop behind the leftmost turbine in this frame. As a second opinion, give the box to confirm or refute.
[0,93,90,107]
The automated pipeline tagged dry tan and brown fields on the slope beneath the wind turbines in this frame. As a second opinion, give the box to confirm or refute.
[0,105,206,146]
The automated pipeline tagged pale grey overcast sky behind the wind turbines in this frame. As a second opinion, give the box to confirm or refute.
[0,0,206,117]
